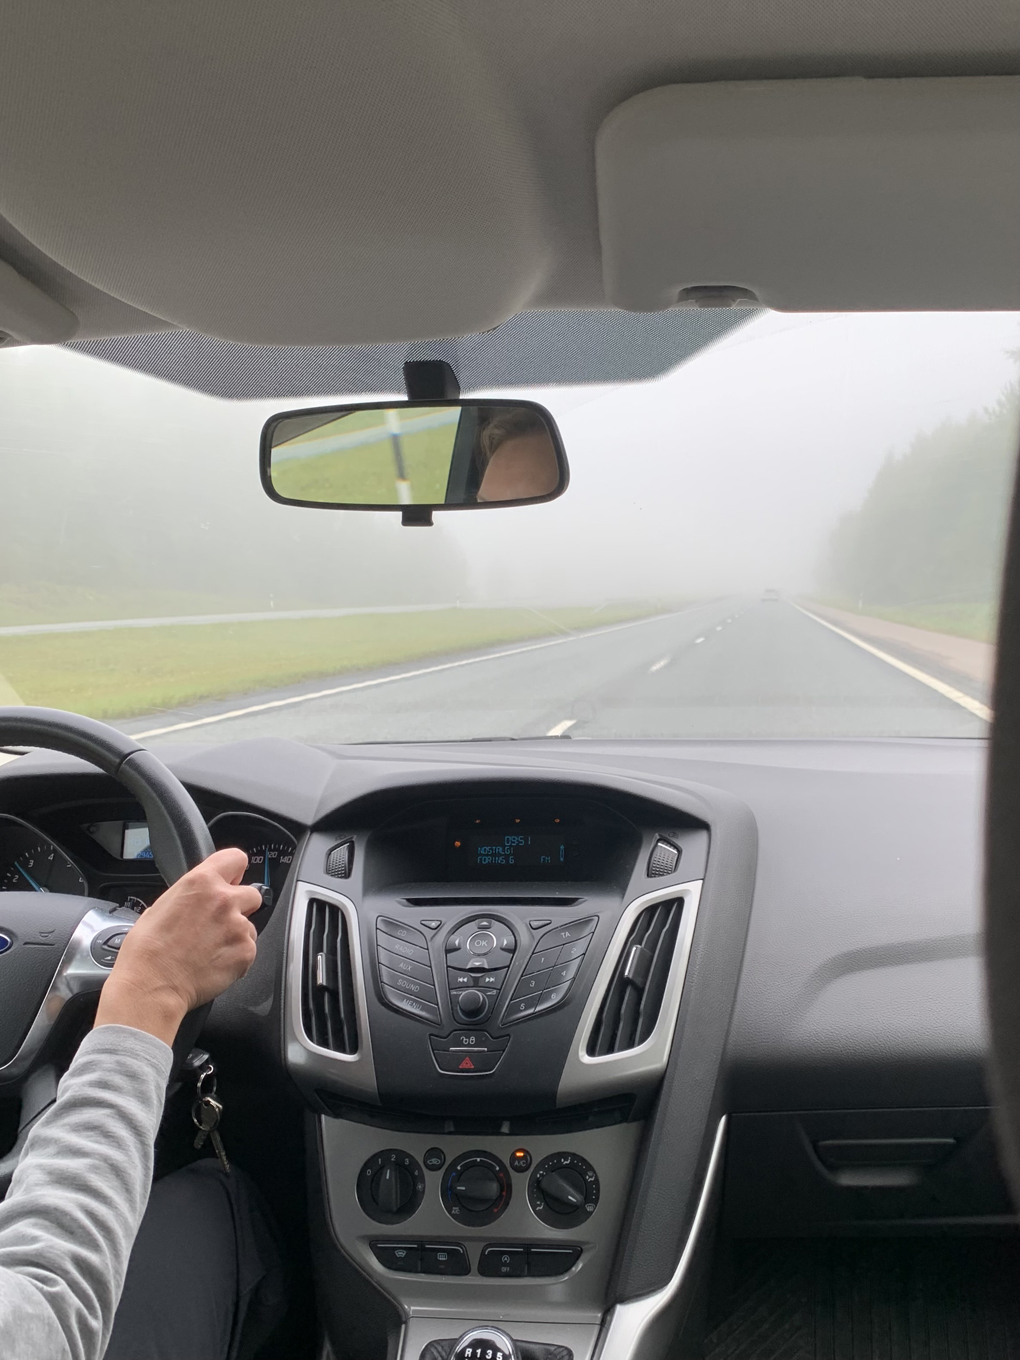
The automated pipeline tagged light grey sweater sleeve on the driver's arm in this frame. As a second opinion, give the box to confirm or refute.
[0,1025,173,1360]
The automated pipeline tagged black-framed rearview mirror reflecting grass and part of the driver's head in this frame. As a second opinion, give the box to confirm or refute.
[261,401,568,524]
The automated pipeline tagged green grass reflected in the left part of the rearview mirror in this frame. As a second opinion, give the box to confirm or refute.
[272,408,457,506]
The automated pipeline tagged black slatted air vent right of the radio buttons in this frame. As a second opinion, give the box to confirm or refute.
[588,898,684,1058]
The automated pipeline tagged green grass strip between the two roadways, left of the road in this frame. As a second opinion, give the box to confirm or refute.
[0,602,666,718]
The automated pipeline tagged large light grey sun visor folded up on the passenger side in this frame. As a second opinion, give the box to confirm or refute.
[596,76,1020,311]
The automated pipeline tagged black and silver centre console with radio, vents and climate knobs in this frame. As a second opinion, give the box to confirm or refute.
[286,785,745,1360]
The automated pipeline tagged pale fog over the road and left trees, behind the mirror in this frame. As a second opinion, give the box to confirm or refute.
[0,314,1020,616]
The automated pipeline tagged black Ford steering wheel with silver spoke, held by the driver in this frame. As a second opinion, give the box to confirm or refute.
[0,707,214,1193]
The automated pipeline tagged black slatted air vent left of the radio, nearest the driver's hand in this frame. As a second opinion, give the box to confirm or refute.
[301,898,358,1053]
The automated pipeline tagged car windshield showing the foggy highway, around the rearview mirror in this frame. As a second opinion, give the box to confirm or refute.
[0,314,1020,745]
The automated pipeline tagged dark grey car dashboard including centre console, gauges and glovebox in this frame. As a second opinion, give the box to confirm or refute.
[0,740,1015,1360]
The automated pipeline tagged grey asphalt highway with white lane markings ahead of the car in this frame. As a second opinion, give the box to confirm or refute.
[120,598,987,747]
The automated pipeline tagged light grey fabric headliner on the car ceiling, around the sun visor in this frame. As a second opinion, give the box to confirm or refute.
[0,0,1020,383]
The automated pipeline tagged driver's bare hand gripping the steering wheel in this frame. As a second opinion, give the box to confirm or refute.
[95,850,262,1043]
